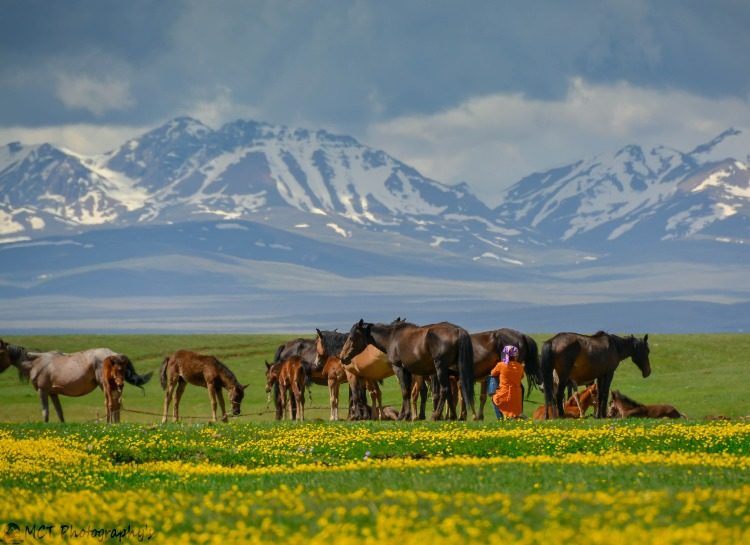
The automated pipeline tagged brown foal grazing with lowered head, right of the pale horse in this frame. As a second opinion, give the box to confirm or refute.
[159,350,247,423]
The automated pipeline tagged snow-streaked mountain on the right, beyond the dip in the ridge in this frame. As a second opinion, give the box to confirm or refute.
[496,129,750,246]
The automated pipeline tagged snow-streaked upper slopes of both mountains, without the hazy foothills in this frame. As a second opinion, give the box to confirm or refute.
[0,117,750,258]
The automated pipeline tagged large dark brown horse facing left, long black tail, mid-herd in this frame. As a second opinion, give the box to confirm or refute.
[340,320,474,420]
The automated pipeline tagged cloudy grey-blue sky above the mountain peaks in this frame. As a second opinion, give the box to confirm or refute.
[0,0,750,204]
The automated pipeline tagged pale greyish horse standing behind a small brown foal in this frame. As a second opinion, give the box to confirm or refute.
[29,348,151,422]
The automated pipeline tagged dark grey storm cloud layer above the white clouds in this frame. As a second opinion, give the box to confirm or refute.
[0,0,750,127]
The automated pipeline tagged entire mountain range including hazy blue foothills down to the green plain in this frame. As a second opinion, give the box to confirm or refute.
[0,117,750,331]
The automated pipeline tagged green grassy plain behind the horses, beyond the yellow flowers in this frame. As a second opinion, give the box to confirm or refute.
[0,334,750,423]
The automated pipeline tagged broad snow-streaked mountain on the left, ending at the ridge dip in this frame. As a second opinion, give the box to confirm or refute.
[0,118,518,259]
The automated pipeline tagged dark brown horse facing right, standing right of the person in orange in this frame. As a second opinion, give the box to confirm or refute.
[541,331,651,418]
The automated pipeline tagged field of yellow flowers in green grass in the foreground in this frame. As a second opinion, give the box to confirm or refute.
[0,421,750,545]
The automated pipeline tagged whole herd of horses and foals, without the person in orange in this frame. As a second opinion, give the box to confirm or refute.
[0,318,683,422]
